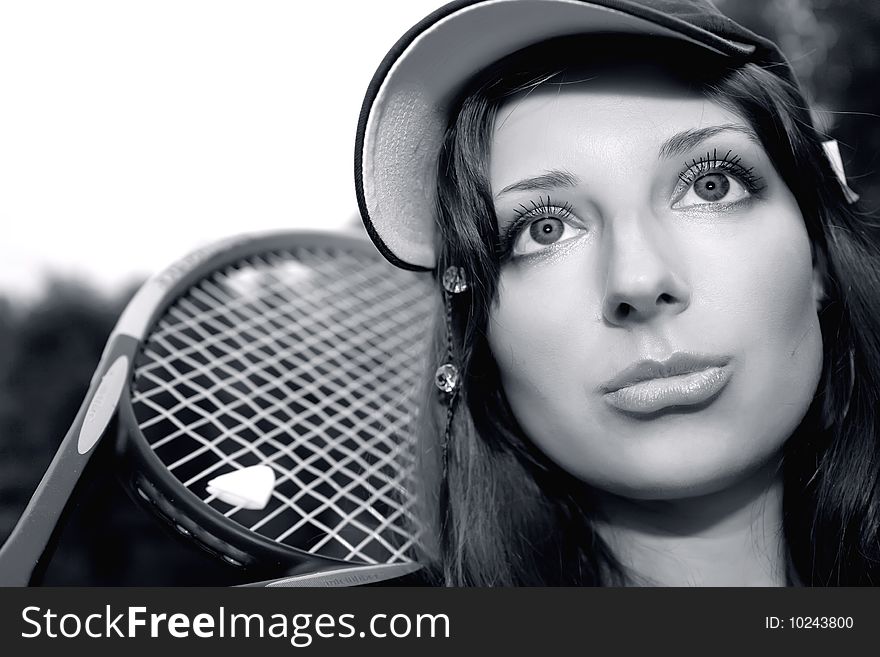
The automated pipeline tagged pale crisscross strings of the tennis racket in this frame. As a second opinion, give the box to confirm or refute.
[132,249,431,563]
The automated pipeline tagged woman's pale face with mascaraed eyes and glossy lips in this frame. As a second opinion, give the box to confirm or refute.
[488,72,822,499]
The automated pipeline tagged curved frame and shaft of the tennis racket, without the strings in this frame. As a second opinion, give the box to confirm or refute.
[0,231,426,586]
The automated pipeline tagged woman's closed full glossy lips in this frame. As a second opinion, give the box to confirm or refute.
[599,352,731,414]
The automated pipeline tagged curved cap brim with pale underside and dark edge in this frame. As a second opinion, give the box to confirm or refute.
[355,0,754,270]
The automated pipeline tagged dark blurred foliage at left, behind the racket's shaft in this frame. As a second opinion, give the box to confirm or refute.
[0,281,248,586]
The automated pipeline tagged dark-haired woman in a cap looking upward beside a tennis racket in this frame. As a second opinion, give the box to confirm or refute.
[356,0,880,586]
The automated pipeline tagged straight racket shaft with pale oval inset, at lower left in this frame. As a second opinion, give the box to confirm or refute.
[0,335,138,586]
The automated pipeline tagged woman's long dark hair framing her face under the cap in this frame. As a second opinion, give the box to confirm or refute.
[419,36,880,586]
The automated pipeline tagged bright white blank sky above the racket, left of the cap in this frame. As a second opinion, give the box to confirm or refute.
[0,0,444,296]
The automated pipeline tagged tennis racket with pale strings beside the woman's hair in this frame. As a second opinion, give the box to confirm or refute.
[0,232,437,586]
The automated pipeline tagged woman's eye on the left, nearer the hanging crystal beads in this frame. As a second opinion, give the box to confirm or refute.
[505,198,586,258]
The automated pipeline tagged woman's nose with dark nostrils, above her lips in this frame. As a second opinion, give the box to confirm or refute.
[602,219,691,326]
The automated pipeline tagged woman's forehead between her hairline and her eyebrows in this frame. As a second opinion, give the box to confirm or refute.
[490,69,745,183]
